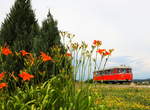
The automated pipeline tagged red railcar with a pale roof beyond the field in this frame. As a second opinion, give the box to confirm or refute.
[93,66,133,83]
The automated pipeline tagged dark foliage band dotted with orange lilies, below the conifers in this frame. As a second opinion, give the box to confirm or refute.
[0,47,72,91]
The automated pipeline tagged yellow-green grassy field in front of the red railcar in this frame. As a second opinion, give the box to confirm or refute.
[91,84,150,110]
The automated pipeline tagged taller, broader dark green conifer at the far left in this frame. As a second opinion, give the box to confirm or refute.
[0,0,39,51]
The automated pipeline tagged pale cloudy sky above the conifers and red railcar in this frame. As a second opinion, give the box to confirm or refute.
[0,0,150,79]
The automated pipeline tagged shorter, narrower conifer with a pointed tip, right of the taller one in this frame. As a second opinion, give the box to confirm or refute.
[41,11,61,51]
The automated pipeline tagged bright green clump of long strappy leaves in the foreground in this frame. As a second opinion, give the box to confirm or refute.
[0,75,101,110]
